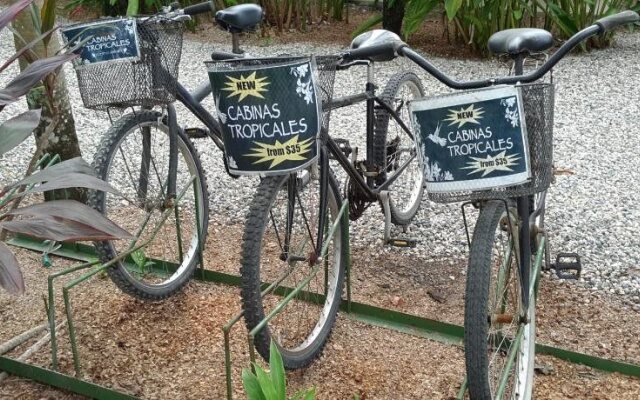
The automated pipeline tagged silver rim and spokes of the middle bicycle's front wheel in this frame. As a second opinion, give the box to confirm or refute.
[245,168,344,368]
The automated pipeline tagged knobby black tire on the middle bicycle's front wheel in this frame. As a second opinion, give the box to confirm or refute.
[240,165,349,369]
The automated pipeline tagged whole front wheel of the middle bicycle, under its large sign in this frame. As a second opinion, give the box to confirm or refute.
[240,167,348,369]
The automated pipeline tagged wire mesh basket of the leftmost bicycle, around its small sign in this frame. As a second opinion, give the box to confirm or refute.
[65,16,184,110]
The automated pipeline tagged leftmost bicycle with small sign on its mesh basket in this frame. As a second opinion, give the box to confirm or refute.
[58,2,263,300]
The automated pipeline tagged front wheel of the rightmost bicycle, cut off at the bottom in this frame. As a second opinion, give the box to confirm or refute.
[464,201,535,400]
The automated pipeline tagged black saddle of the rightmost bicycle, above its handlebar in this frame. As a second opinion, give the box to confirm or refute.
[488,28,553,54]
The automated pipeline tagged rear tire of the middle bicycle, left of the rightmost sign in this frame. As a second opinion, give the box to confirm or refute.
[373,72,424,226]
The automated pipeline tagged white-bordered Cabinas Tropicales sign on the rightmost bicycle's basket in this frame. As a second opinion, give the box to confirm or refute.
[410,86,531,192]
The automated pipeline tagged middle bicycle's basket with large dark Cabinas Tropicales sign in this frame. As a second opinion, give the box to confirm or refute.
[205,56,339,175]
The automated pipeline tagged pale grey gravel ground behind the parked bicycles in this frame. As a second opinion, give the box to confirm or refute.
[0,25,640,304]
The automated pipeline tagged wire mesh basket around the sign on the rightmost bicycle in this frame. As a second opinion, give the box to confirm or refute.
[427,83,554,203]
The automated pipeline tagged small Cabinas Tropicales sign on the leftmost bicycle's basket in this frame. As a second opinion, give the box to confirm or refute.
[61,18,140,65]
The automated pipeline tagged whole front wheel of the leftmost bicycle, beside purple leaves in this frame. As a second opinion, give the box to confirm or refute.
[90,111,209,300]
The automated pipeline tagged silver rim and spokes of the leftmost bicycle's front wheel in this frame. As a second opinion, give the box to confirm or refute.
[103,121,206,290]
